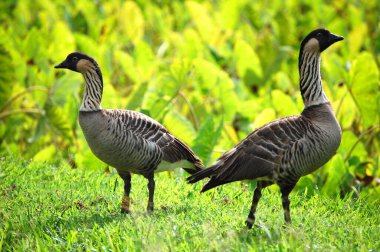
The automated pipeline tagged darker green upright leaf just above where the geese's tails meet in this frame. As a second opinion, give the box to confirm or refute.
[193,117,223,165]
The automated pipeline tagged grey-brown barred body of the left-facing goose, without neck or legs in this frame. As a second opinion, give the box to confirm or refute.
[79,109,200,177]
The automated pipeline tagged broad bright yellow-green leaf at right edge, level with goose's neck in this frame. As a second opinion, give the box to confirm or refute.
[348,52,380,128]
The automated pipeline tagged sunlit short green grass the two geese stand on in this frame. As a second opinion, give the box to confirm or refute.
[0,158,380,251]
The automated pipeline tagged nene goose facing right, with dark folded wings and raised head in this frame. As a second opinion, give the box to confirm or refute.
[188,29,343,228]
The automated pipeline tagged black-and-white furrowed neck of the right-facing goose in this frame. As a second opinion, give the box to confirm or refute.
[298,51,329,108]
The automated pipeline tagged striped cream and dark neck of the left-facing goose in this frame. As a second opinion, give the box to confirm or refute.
[80,67,103,111]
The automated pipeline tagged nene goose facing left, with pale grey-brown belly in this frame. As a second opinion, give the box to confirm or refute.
[55,52,202,213]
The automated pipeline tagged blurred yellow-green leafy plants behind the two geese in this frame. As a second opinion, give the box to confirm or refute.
[0,0,380,248]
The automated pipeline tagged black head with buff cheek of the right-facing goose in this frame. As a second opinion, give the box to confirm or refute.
[301,29,343,53]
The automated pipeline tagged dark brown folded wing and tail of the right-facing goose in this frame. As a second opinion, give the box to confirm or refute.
[196,116,306,191]
